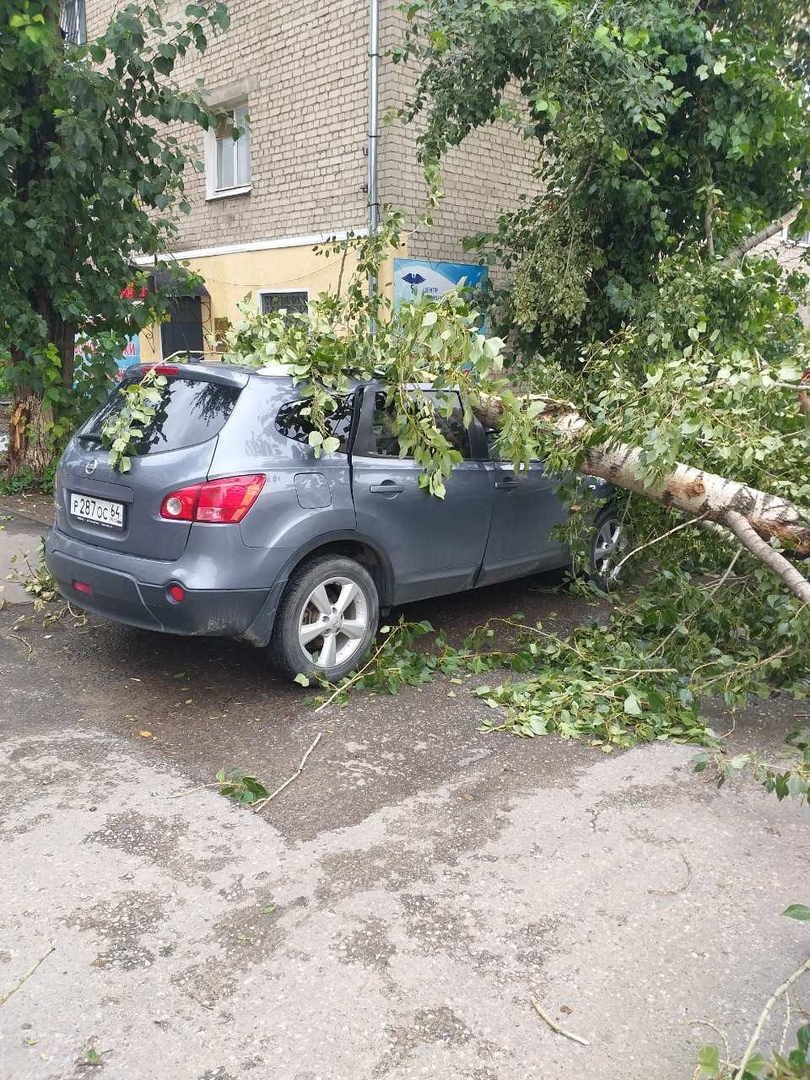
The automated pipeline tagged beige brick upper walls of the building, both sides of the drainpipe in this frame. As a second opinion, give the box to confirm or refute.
[86,0,540,259]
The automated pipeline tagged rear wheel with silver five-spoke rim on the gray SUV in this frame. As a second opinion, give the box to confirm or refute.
[268,555,380,683]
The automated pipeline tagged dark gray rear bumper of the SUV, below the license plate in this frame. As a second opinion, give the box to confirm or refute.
[45,531,284,645]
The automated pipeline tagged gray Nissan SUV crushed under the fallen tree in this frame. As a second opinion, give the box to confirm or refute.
[45,364,622,680]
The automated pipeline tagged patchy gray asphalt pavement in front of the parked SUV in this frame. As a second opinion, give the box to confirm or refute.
[0,507,810,1080]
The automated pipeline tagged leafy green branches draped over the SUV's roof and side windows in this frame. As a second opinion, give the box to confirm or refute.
[216,214,557,498]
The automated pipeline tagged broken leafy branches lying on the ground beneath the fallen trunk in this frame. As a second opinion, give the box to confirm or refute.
[306,537,810,751]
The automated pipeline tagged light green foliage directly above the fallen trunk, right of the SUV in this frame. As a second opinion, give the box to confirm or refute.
[544,256,810,504]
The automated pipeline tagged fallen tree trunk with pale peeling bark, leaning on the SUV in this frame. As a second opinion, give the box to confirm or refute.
[473,397,810,605]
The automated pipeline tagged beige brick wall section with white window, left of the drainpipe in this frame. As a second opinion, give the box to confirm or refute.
[87,0,367,249]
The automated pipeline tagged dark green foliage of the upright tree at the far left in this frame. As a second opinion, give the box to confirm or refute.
[0,0,228,464]
